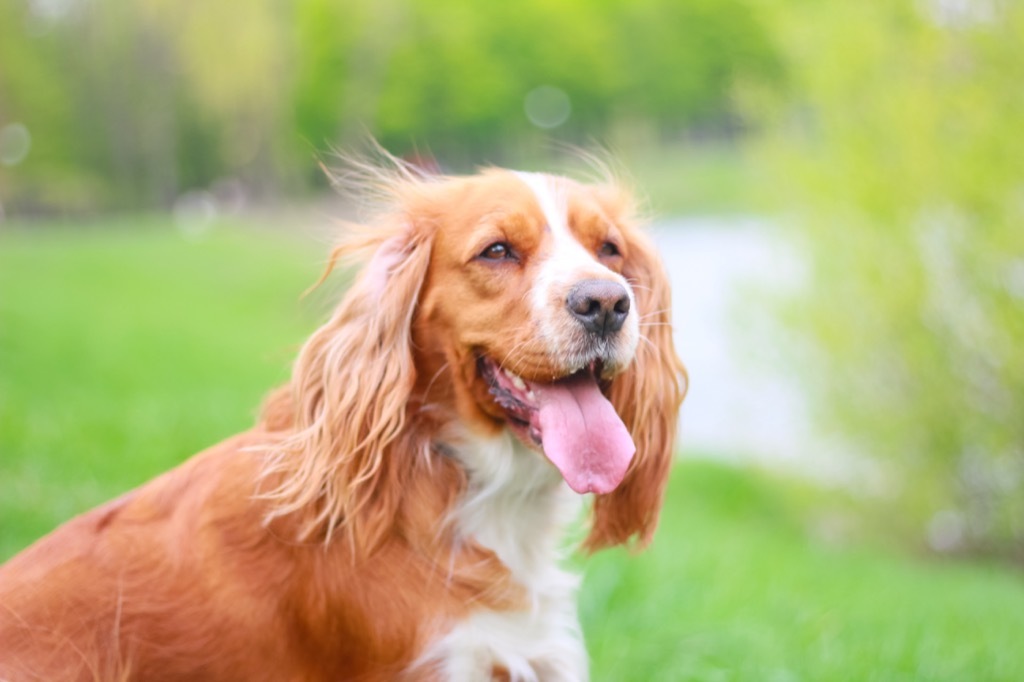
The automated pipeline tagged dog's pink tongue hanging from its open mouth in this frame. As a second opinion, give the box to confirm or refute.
[532,372,636,495]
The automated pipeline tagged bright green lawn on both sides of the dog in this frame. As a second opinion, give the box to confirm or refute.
[0,218,1024,682]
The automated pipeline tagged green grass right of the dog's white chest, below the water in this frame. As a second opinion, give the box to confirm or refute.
[582,462,1024,682]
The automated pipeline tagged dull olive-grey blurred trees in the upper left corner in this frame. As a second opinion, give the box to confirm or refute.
[0,0,290,211]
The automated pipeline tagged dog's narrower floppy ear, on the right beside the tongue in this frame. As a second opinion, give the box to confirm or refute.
[584,228,687,552]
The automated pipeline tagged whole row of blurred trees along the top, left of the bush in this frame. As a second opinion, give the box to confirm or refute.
[0,0,779,212]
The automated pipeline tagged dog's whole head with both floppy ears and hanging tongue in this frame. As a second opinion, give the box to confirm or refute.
[264,163,685,549]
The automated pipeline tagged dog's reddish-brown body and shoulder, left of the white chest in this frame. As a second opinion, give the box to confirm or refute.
[0,430,514,682]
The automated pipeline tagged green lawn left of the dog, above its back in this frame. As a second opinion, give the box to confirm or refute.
[0,219,323,558]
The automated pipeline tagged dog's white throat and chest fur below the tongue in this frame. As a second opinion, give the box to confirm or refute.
[415,433,587,682]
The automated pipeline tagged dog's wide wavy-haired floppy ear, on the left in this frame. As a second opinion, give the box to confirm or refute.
[261,224,431,551]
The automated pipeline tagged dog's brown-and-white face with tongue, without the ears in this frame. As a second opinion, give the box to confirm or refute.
[416,166,640,493]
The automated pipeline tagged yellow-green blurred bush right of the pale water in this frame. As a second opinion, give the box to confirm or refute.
[751,0,1024,560]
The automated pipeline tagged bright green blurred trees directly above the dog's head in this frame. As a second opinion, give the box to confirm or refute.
[339,0,779,159]
